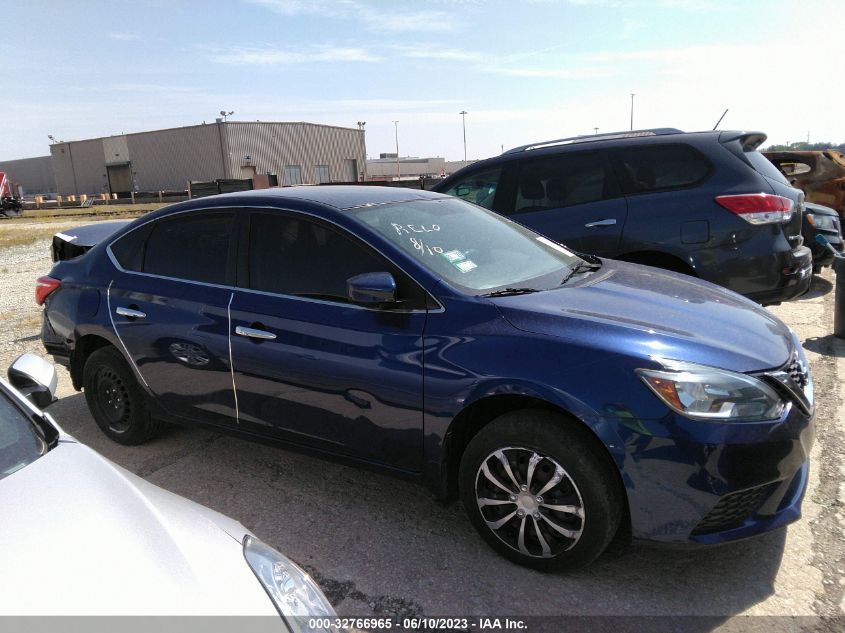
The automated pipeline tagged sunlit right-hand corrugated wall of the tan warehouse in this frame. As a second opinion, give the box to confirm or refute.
[224,121,367,184]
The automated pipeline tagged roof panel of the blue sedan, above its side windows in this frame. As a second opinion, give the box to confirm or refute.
[199,185,449,210]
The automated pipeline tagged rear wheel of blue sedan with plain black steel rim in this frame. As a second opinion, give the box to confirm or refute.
[82,347,164,446]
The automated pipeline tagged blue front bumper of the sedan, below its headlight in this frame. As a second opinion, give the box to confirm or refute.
[623,404,814,544]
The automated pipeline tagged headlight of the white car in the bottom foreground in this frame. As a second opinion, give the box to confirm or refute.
[244,536,335,633]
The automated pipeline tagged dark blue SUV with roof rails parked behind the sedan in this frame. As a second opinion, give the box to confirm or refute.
[434,128,812,305]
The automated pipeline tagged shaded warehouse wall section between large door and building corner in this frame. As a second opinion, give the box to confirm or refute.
[126,123,226,191]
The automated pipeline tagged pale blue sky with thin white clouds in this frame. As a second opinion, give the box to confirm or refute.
[0,0,845,160]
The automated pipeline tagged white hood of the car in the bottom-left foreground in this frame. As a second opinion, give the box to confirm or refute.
[0,437,278,617]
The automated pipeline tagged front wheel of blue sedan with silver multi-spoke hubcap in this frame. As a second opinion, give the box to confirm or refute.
[458,410,625,570]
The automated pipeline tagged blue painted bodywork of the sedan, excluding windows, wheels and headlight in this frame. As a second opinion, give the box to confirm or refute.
[42,187,813,543]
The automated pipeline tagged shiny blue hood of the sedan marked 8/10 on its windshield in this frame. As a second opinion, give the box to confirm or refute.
[491,259,793,372]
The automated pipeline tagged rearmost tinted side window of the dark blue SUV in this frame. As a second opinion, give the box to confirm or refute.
[612,145,708,193]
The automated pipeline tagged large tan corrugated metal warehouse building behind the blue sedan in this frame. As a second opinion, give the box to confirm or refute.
[50,121,367,195]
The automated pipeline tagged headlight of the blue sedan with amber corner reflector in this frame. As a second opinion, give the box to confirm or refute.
[636,361,786,422]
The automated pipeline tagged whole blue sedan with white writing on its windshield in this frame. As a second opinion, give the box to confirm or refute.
[37,186,813,568]
